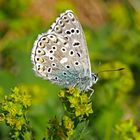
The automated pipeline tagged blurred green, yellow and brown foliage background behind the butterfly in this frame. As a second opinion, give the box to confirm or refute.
[0,0,140,140]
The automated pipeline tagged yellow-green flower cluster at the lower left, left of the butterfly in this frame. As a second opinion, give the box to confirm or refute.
[0,87,31,137]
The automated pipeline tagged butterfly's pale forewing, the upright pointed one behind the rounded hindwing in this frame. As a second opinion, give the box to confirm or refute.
[49,10,91,74]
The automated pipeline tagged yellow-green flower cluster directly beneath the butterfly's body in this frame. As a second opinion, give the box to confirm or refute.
[59,87,93,117]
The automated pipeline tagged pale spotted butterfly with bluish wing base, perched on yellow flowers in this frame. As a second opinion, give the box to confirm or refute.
[31,10,98,91]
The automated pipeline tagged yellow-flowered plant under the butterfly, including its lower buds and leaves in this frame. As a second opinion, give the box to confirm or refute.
[47,87,93,140]
